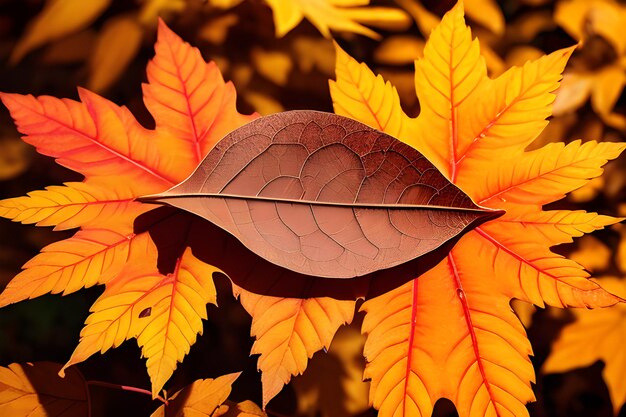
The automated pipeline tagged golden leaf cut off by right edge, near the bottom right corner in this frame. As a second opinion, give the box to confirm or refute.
[542,277,626,415]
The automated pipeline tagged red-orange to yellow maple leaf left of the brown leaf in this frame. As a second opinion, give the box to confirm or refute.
[0,22,256,395]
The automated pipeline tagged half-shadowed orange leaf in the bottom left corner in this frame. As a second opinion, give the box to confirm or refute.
[0,362,89,417]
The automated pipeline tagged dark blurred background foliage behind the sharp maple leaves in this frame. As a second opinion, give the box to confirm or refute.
[0,0,626,417]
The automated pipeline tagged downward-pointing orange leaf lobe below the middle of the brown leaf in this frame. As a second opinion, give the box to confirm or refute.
[233,286,356,408]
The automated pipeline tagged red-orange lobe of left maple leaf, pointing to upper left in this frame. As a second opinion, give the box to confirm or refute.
[0,89,180,196]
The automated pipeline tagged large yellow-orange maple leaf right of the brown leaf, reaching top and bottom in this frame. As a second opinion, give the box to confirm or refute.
[330,5,625,417]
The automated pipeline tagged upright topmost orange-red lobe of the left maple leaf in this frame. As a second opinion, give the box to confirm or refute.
[143,20,257,166]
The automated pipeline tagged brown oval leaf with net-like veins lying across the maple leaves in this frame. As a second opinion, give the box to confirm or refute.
[141,111,501,278]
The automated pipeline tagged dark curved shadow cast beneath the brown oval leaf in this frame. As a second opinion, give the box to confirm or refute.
[135,207,501,300]
